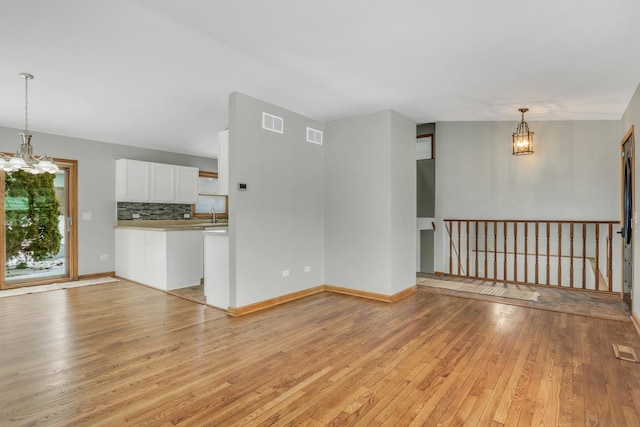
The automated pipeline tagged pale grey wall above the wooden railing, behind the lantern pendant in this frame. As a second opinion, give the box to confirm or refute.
[435,121,621,271]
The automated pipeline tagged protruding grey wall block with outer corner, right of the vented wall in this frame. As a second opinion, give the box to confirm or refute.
[325,111,416,295]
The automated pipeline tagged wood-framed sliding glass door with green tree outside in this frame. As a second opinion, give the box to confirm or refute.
[0,161,77,288]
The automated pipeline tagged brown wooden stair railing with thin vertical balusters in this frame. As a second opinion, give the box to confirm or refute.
[444,219,619,291]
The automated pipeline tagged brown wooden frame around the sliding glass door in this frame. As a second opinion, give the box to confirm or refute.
[0,158,78,289]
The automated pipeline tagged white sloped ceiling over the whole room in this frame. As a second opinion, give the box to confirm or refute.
[0,0,640,157]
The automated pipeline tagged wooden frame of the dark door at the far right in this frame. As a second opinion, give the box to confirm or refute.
[620,125,637,310]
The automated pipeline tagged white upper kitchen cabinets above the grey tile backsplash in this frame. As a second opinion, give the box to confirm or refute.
[116,159,198,204]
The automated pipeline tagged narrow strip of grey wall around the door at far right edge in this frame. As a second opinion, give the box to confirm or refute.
[618,85,640,318]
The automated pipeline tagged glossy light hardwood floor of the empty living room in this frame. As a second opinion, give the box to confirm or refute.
[0,281,640,426]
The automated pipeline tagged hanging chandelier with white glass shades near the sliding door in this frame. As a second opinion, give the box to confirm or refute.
[0,73,60,174]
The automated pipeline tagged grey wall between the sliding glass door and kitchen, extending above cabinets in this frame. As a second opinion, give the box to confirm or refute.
[0,127,218,275]
